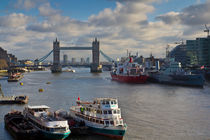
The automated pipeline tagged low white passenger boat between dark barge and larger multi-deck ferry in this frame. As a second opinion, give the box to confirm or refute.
[23,105,70,140]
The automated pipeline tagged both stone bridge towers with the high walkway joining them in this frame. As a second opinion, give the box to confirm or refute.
[51,38,102,73]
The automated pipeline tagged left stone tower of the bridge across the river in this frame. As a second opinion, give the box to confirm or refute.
[51,38,62,73]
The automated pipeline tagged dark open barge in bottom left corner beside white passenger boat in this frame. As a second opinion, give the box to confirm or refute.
[4,111,39,140]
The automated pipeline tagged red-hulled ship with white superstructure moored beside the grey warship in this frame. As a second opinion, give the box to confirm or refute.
[111,57,148,83]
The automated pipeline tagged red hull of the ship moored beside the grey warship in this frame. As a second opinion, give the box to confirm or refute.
[111,73,148,84]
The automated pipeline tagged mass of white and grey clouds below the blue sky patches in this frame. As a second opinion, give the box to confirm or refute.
[0,0,210,59]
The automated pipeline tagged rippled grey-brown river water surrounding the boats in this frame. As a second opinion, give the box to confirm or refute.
[0,68,210,140]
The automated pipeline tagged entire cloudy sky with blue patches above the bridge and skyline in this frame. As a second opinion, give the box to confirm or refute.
[0,0,210,60]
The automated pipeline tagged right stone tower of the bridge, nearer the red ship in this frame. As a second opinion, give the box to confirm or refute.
[90,38,102,72]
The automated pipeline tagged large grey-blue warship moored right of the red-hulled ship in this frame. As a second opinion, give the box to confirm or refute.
[150,58,205,87]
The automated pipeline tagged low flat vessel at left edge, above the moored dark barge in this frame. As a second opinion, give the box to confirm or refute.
[0,84,28,104]
